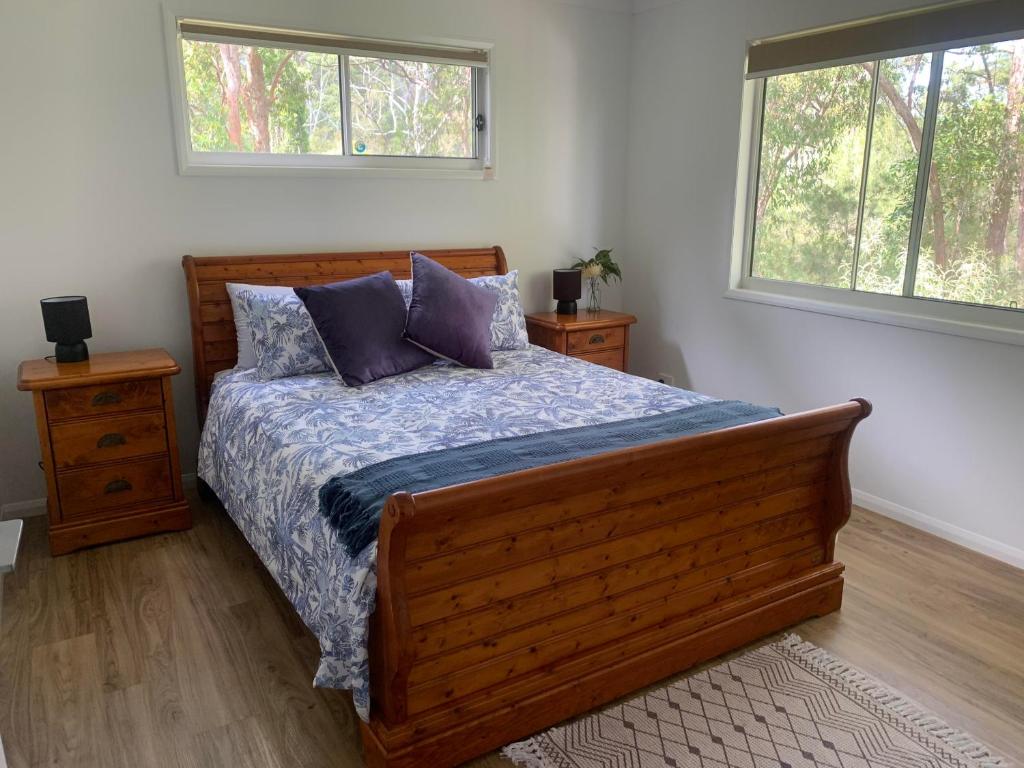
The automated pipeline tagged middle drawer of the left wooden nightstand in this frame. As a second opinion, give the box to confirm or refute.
[50,411,167,469]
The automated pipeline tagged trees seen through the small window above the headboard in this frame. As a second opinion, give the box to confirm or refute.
[182,40,475,158]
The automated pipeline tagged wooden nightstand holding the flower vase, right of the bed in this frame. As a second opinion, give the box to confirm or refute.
[526,309,637,371]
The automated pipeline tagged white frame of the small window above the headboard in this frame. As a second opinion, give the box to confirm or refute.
[164,7,497,180]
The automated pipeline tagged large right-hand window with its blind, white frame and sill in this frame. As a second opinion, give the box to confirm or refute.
[726,0,1024,345]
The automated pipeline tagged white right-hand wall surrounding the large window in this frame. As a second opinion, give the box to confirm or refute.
[623,0,1024,565]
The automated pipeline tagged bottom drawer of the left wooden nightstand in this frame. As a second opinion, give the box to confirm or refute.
[57,456,173,522]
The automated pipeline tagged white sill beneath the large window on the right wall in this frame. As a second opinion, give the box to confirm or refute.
[725,281,1024,346]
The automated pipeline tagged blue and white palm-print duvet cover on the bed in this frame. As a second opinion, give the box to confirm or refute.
[199,346,714,719]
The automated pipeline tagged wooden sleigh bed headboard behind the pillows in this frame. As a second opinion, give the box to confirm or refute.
[181,246,508,425]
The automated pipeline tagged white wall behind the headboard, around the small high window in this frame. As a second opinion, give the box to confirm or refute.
[0,0,630,511]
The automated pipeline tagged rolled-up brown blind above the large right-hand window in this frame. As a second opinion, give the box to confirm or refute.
[746,0,1024,79]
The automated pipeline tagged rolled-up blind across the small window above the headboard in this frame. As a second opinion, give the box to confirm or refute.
[178,18,487,68]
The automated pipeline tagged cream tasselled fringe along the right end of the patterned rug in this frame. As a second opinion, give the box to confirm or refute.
[782,634,1012,768]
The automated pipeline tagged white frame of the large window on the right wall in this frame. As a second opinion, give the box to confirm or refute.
[724,44,1024,346]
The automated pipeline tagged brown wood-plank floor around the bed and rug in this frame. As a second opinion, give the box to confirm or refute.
[0,493,1024,768]
